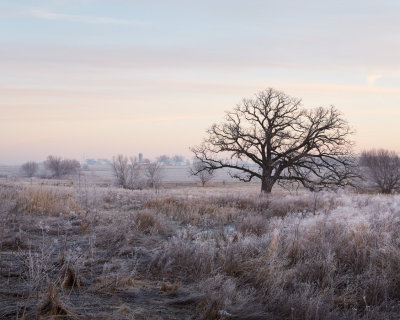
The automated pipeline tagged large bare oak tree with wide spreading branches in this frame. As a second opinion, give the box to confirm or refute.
[191,88,354,193]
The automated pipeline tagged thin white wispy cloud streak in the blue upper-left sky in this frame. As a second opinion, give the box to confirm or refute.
[25,9,146,25]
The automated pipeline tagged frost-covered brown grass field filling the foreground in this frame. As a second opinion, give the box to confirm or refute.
[0,183,400,319]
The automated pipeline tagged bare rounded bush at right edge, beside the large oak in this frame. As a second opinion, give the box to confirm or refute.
[360,149,400,194]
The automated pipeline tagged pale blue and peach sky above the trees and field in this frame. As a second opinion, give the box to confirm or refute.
[0,0,400,164]
